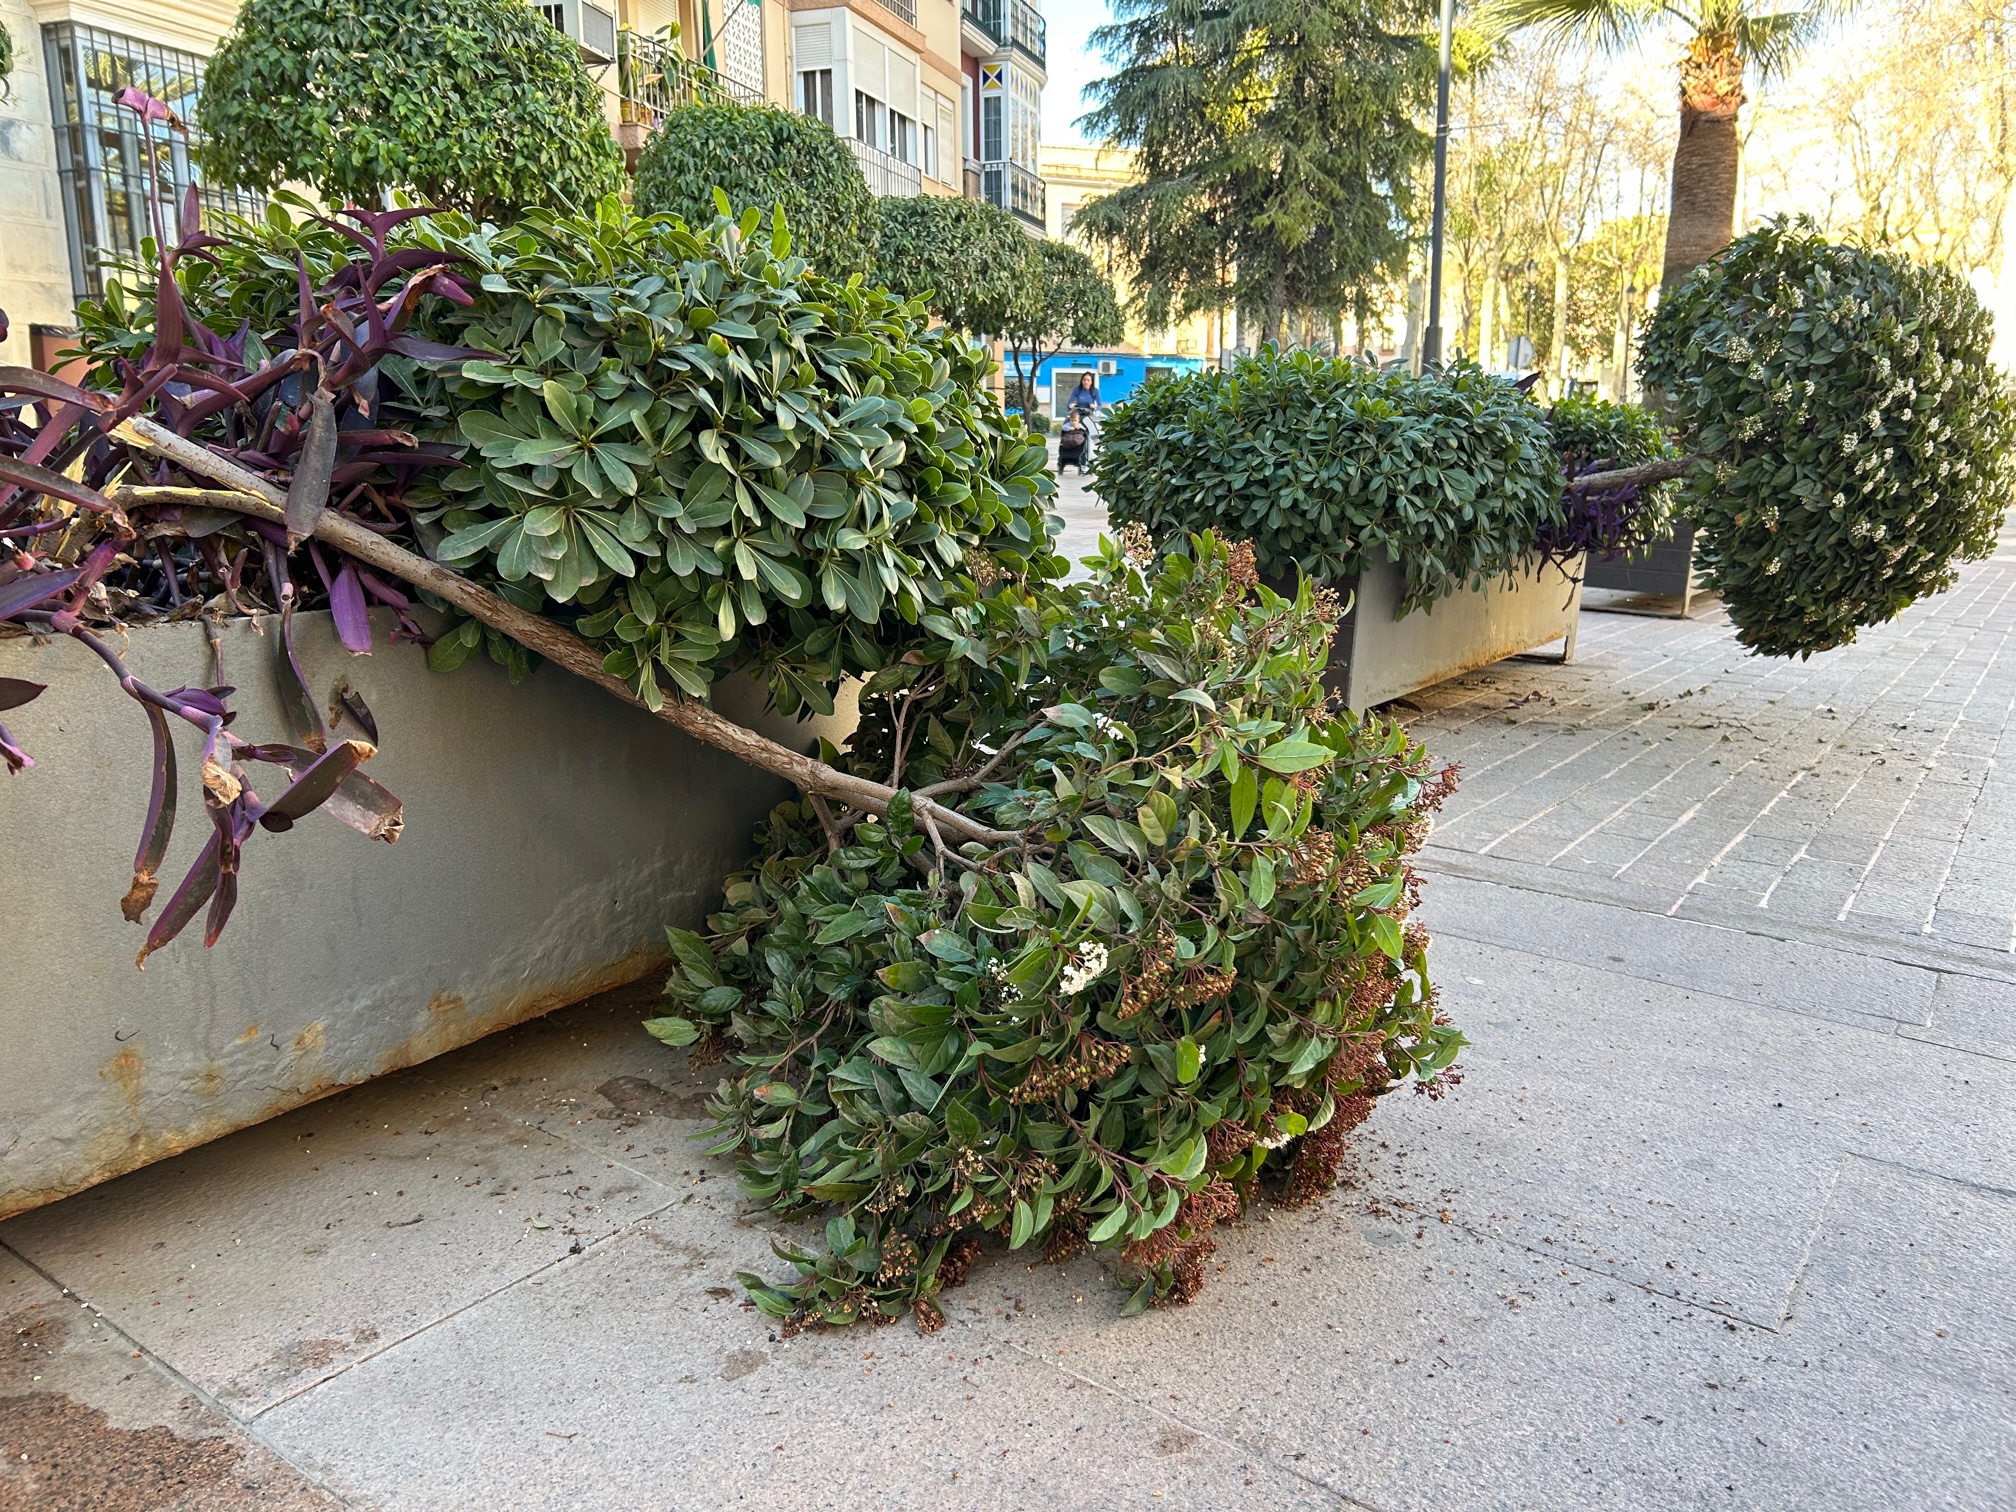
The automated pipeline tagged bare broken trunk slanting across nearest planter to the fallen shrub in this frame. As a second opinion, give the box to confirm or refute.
[105,415,1022,845]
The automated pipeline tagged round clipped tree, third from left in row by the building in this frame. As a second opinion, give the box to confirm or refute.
[875,194,1030,337]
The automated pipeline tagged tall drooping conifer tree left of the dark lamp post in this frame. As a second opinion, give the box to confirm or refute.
[1073,0,1435,341]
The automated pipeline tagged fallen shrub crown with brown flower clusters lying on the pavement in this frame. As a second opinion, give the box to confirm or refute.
[651,536,1464,1331]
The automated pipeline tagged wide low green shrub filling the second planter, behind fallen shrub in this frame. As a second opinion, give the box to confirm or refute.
[1093,351,1560,609]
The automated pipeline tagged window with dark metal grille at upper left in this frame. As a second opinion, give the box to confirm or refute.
[42,22,264,298]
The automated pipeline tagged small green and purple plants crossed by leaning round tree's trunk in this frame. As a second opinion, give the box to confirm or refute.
[1538,395,1679,562]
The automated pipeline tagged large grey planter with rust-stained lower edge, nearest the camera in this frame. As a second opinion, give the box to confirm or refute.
[0,615,851,1216]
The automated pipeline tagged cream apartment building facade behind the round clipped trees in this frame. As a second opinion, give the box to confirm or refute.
[0,0,1044,365]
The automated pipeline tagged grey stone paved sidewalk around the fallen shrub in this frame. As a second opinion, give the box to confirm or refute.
[0,532,2016,1512]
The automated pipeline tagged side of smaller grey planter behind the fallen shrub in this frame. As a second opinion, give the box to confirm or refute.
[1298,558,1583,714]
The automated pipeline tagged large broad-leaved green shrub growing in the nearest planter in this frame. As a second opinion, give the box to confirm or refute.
[85,198,1054,710]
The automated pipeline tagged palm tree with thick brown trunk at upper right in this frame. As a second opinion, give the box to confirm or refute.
[1496,0,1843,292]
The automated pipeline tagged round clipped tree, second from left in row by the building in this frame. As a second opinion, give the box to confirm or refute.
[631,105,879,280]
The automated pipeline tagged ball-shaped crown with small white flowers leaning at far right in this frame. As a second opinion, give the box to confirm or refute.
[1639,220,2016,657]
